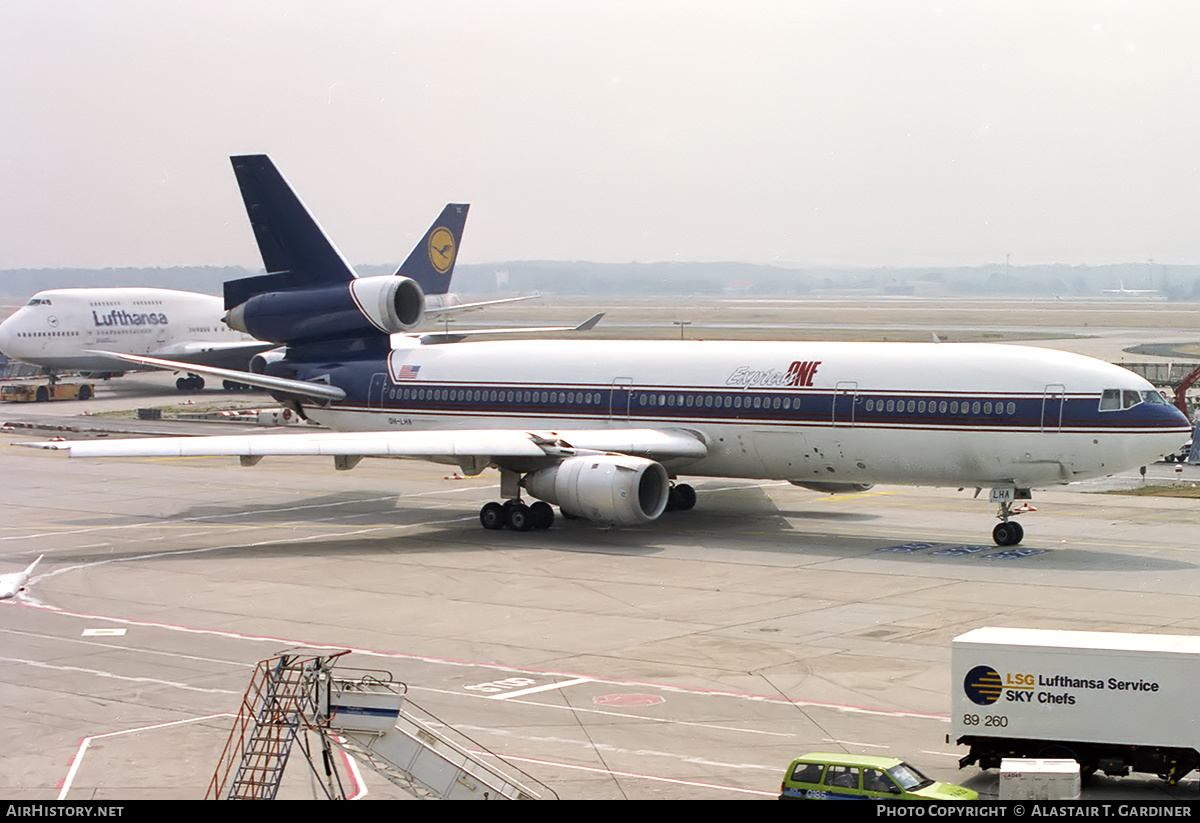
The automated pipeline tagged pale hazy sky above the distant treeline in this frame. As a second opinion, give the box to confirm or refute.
[0,0,1200,268]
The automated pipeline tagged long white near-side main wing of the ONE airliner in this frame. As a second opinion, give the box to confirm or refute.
[23,428,708,469]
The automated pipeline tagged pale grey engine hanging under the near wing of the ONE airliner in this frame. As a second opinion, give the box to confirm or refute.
[524,455,671,525]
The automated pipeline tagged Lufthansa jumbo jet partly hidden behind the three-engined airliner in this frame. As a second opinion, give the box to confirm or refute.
[0,203,487,391]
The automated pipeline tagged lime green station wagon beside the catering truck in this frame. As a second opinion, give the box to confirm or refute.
[779,752,979,800]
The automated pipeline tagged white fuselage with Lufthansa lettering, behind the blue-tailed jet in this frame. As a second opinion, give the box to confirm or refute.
[0,288,254,372]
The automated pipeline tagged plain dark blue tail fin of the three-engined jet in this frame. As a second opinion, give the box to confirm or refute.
[224,155,355,308]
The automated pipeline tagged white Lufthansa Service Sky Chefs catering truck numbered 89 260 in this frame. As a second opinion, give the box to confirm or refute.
[947,627,1200,785]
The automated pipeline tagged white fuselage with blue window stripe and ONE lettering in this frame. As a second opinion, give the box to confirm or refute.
[301,341,1190,487]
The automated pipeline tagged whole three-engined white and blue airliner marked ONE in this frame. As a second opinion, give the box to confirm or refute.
[35,155,1192,546]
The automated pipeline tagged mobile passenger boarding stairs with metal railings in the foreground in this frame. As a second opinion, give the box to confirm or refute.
[206,650,557,800]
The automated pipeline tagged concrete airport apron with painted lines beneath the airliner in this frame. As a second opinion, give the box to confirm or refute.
[0,377,1200,800]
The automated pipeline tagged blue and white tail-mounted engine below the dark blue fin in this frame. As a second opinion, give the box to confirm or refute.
[224,275,425,343]
